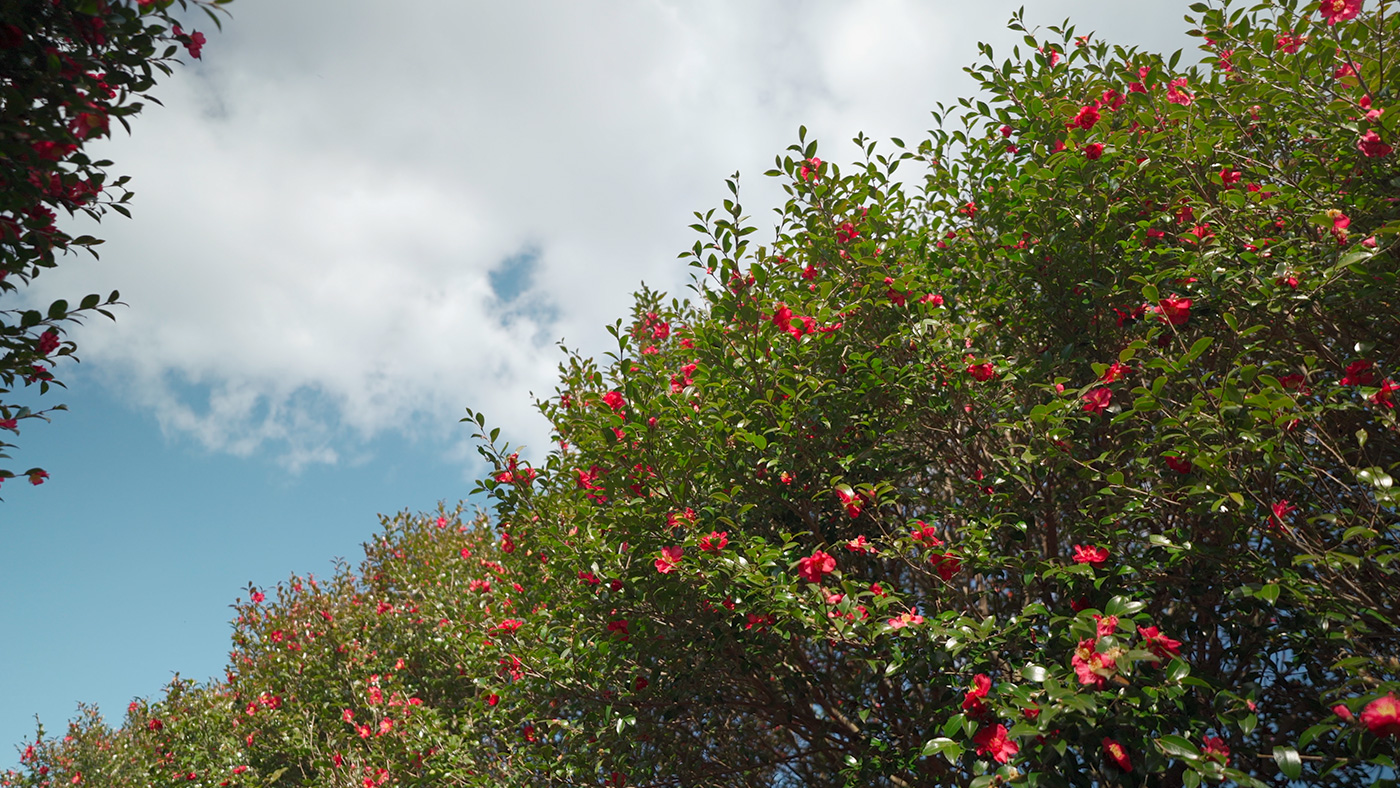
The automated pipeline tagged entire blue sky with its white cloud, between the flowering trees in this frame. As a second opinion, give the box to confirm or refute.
[0,0,1194,768]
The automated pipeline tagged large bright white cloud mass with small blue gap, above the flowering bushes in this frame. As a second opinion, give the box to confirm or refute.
[24,0,1180,467]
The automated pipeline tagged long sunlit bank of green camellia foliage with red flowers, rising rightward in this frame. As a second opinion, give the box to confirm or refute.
[7,0,1400,788]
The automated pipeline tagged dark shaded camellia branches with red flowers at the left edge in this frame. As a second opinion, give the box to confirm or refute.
[0,0,231,484]
